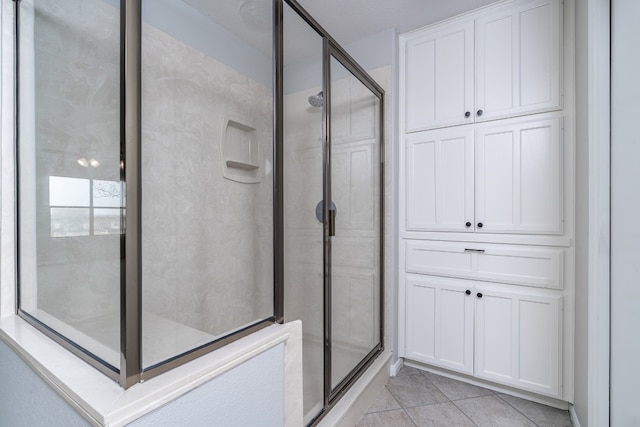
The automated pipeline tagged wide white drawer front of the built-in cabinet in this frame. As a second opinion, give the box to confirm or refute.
[406,241,564,289]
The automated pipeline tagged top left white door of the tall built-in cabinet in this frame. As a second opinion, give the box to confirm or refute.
[402,20,473,132]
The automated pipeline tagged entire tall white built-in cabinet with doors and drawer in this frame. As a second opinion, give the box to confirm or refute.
[398,0,575,401]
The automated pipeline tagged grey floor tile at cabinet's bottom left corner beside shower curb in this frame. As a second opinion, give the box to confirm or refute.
[387,368,449,408]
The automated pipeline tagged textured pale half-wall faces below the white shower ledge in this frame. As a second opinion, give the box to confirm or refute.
[0,341,284,427]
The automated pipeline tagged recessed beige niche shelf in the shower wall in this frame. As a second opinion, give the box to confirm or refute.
[221,119,262,184]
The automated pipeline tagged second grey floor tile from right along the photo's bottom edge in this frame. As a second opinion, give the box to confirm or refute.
[454,395,536,427]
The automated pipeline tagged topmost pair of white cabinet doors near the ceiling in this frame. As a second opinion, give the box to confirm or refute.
[400,0,562,133]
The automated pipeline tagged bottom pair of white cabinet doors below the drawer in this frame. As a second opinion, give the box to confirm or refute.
[401,275,562,397]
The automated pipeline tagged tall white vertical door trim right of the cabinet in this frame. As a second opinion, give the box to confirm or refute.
[587,0,611,426]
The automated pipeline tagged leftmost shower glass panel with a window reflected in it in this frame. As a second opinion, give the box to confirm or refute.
[16,0,124,370]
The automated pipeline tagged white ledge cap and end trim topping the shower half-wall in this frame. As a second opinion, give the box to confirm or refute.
[0,315,302,427]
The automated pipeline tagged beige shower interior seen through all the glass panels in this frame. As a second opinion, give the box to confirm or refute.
[19,0,382,423]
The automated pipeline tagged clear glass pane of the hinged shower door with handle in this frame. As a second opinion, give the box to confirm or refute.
[331,57,381,388]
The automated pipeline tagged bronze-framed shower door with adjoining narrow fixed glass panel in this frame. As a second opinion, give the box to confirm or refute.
[283,1,384,423]
